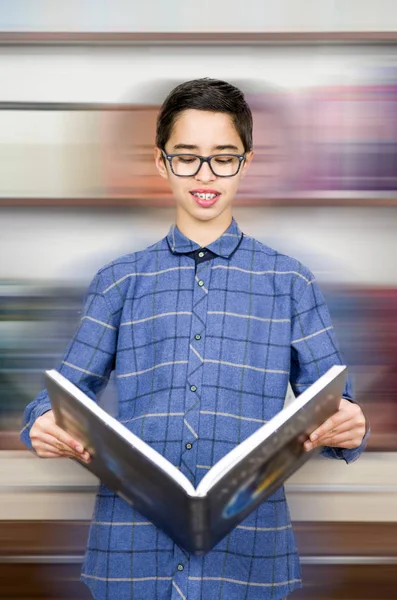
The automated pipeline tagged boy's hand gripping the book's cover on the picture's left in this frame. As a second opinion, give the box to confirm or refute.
[30,410,90,463]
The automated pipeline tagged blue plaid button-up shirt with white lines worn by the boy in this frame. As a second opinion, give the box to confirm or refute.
[21,219,365,600]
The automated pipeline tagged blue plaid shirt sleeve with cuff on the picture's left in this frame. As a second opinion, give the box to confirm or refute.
[20,273,118,450]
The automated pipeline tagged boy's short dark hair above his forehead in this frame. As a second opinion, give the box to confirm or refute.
[156,77,252,152]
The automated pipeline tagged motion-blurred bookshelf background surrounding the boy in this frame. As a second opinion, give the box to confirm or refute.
[0,0,397,600]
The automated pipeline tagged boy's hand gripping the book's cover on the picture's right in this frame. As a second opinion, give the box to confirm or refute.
[304,398,365,450]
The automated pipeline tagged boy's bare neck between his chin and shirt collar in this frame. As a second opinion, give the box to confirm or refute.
[176,211,232,248]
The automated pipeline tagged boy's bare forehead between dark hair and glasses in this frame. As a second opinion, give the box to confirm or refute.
[167,109,243,149]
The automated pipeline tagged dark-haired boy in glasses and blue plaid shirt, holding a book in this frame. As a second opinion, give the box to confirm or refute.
[21,78,366,600]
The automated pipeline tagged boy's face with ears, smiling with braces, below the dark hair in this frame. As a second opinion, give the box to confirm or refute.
[155,109,253,227]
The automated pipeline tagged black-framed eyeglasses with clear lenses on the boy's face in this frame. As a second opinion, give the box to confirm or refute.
[161,150,245,177]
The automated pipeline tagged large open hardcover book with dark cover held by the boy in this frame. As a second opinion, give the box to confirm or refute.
[46,366,347,554]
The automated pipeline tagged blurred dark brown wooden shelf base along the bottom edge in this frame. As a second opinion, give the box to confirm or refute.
[0,521,397,600]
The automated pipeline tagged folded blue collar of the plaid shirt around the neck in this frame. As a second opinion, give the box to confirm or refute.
[167,218,243,258]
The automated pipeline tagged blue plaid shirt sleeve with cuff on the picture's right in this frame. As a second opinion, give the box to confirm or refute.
[290,276,370,463]
